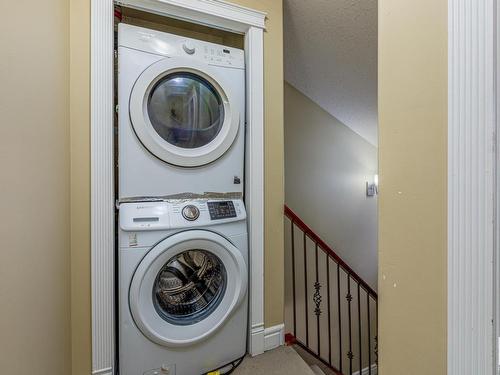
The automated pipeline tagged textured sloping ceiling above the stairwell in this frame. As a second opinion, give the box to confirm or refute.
[284,0,377,145]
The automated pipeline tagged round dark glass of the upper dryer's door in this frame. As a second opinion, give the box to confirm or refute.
[147,73,224,149]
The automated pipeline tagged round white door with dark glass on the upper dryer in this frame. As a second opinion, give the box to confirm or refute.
[130,58,240,167]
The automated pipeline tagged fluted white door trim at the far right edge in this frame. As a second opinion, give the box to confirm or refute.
[448,0,500,375]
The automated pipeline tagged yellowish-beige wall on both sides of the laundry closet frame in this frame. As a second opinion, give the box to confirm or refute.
[70,0,284,375]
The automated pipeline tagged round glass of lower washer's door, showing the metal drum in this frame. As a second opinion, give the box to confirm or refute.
[153,250,227,325]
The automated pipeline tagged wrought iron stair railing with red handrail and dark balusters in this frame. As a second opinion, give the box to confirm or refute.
[285,206,378,375]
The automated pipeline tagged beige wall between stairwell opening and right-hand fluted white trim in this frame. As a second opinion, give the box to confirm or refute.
[379,0,447,375]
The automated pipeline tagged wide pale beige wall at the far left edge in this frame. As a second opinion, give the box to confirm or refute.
[0,0,71,375]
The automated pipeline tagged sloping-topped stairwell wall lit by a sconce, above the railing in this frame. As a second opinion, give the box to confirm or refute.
[285,83,378,290]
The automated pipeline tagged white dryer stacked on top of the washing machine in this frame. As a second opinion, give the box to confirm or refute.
[118,23,245,199]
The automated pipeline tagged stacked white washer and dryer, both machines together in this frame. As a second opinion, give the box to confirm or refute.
[118,23,248,375]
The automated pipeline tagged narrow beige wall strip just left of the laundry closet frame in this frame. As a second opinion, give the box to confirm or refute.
[70,0,92,375]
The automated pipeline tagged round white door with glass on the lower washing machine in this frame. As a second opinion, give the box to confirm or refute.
[129,230,247,346]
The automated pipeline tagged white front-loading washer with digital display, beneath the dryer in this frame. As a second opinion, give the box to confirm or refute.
[118,200,248,375]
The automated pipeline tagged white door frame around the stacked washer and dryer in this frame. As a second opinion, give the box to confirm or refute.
[90,0,266,375]
